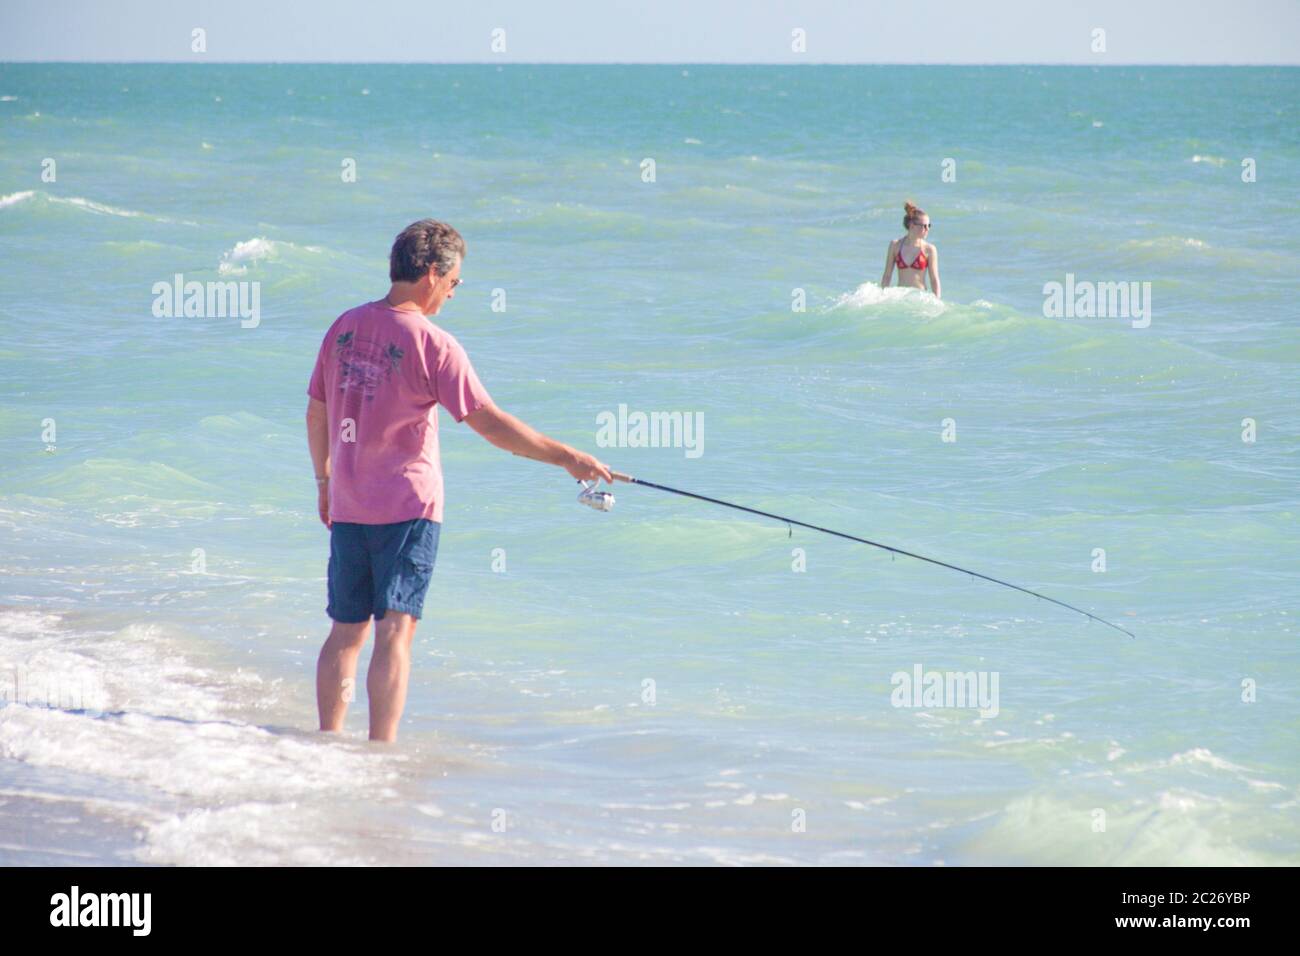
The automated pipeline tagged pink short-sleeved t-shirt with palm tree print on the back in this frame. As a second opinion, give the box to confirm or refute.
[307,300,491,524]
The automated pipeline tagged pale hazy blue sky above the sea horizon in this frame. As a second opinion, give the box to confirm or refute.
[0,0,1300,65]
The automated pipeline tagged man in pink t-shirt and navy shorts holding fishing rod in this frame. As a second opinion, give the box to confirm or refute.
[307,219,612,741]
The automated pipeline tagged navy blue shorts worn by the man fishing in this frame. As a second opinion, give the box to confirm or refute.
[325,518,442,624]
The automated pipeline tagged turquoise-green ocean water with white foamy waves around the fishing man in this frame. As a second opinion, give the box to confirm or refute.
[0,65,1300,865]
